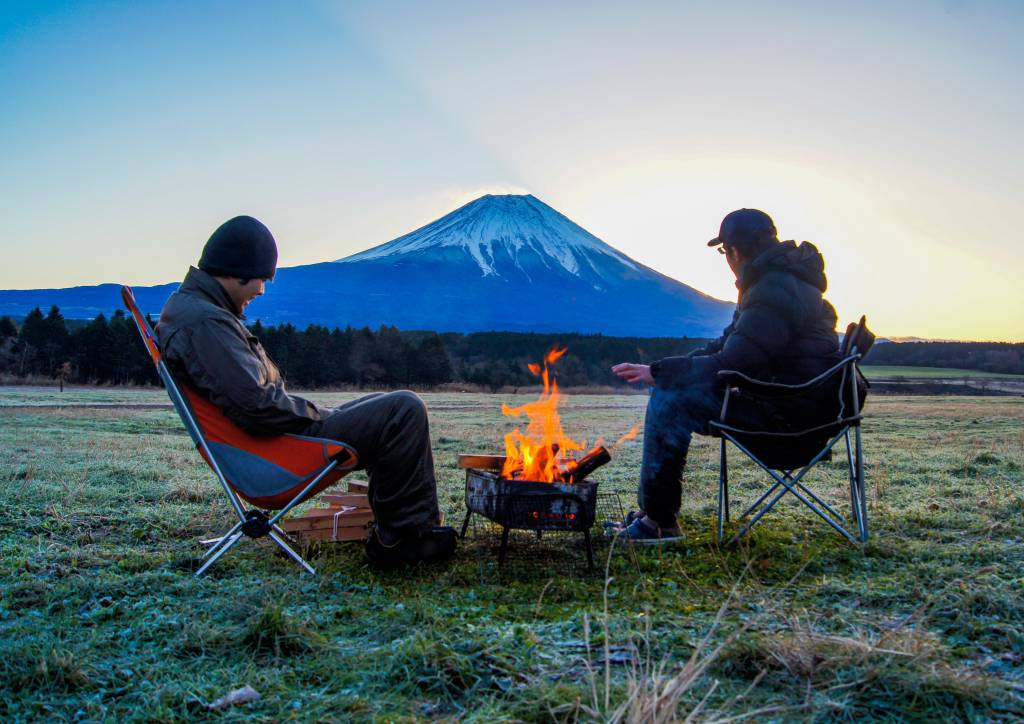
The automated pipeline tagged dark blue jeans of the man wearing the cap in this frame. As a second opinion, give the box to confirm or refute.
[638,386,773,527]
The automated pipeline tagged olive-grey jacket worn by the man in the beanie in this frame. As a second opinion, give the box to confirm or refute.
[157,266,328,435]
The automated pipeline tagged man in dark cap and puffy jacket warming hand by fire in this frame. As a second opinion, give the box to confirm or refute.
[611,209,840,543]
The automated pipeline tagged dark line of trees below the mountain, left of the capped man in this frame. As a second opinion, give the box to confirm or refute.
[0,306,700,389]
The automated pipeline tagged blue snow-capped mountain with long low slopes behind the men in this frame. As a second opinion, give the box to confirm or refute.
[0,196,733,337]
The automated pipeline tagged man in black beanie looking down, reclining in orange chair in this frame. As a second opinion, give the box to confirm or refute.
[157,216,456,568]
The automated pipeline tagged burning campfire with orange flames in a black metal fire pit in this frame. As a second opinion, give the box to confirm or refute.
[459,347,637,567]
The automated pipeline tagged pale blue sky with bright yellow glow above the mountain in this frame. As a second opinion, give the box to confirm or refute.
[0,0,1024,341]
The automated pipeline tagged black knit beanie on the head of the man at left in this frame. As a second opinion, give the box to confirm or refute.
[199,216,278,280]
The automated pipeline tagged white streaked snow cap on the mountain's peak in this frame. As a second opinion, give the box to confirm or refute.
[338,194,637,276]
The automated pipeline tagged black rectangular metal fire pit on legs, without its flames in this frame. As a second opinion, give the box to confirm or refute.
[459,455,597,569]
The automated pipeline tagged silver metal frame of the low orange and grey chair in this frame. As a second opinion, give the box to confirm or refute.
[121,287,357,578]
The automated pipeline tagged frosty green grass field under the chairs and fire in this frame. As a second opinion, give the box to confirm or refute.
[0,388,1024,721]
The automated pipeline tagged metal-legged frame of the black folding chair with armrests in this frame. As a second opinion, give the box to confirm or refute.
[710,318,873,545]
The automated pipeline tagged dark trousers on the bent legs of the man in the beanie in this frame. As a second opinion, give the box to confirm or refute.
[305,390,440,539]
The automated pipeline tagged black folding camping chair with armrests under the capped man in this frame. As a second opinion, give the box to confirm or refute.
[710,316,874,544]
